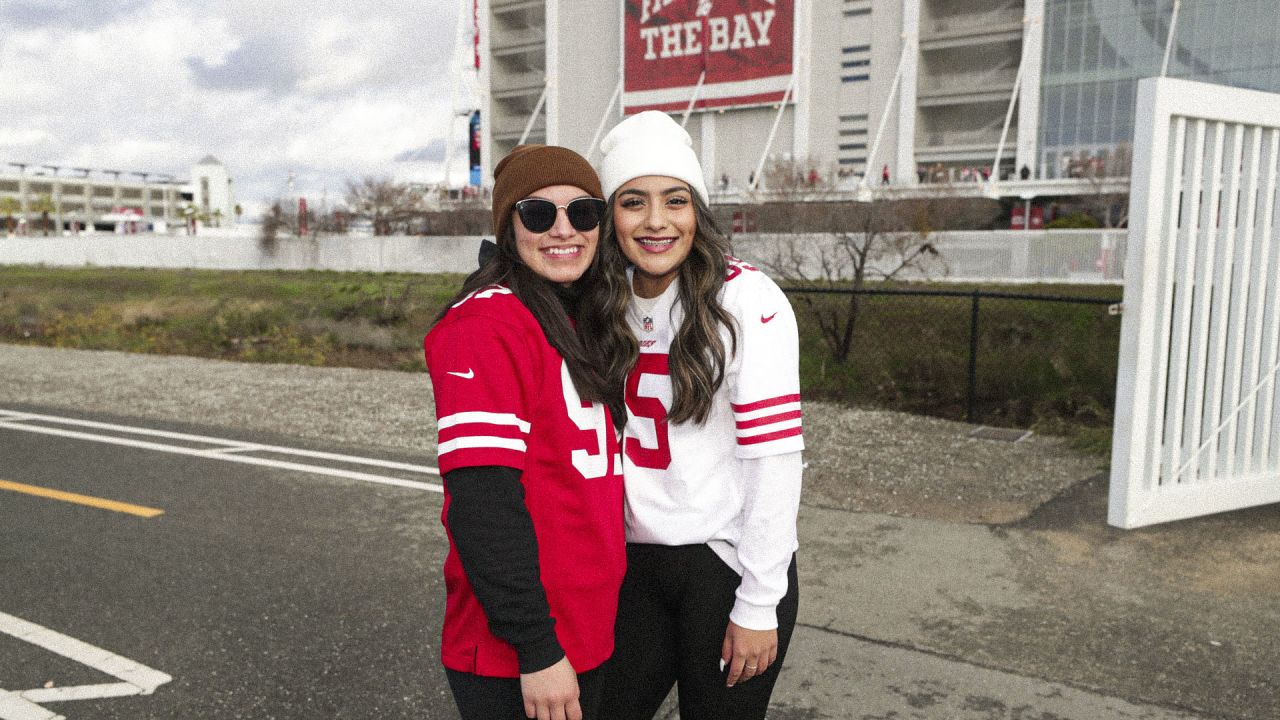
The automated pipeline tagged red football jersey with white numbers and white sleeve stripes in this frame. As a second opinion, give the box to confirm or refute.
[424,286,626,678]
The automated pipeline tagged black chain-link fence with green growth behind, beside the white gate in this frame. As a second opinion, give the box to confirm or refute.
[783,287,1120,432]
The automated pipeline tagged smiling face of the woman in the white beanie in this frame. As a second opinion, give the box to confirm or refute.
[613,176,698,297]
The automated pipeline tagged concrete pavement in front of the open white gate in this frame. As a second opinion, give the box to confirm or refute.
[752,477,1280,720]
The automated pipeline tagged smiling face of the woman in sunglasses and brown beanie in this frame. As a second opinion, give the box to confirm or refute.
[511,184,600,284]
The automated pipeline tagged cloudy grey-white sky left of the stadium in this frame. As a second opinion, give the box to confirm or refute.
[0,0,466,209]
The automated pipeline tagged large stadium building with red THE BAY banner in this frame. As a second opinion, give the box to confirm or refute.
[467,0,1280,197]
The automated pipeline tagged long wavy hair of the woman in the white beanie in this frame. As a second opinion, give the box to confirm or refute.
[581,190,737,423]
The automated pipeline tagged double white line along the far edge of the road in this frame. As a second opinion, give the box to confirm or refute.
[0,409,444,489]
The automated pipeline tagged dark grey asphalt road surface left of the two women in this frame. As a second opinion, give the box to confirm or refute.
[0,411,456,720]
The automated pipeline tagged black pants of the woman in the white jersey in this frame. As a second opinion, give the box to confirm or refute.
[600,543,800,720]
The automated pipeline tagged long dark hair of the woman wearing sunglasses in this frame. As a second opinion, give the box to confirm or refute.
[431,225,626,415]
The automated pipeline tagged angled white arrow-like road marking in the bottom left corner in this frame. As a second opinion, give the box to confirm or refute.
[0,604,173,720]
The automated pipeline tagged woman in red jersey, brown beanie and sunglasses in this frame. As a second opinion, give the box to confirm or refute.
[424,145,625,720]
